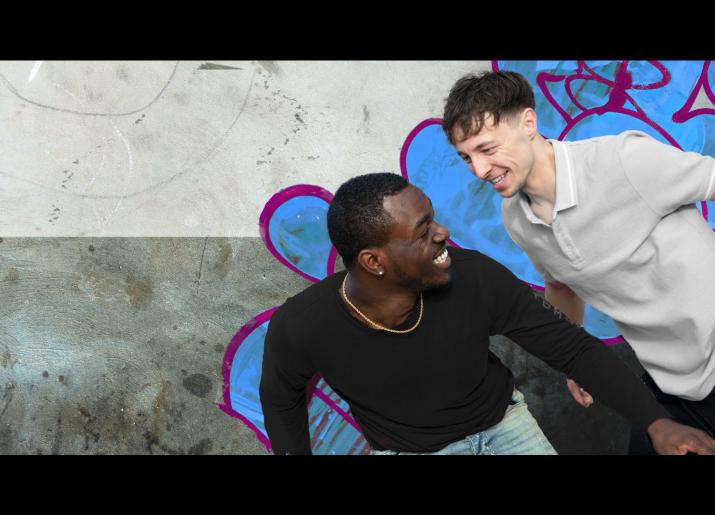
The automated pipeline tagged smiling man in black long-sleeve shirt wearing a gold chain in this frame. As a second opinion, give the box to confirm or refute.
[260,173,715,454]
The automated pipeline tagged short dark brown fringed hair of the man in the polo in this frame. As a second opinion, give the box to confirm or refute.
[442,71,536,145]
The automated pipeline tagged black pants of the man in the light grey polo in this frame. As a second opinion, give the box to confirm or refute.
[628,373,715,454]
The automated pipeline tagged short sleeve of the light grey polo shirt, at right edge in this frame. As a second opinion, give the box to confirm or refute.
[617,131,715,216]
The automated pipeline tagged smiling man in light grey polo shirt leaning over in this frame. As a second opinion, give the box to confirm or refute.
[443,70,715,454]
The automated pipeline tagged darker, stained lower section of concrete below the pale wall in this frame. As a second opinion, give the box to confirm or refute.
[0,238,639,454]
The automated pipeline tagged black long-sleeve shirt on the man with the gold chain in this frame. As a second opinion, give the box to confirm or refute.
[260,248,669,454]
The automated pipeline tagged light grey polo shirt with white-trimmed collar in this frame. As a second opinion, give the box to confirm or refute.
[502,131,715,400]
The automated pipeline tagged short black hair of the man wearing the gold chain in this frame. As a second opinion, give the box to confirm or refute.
[328,173,410,270]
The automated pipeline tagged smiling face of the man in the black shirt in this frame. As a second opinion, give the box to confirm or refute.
[383,185,452,291]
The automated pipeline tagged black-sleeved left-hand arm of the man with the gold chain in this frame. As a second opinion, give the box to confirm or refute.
[259,312,314,454]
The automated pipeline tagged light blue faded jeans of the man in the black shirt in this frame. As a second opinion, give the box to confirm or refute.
[370,388,557,455]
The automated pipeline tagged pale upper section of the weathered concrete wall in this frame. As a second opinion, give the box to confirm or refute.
[0,61,490,237]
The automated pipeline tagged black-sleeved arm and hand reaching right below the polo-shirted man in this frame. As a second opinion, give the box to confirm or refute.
[481,260,715,454]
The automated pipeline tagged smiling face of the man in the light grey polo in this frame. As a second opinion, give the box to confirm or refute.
[454,112,535,198]
